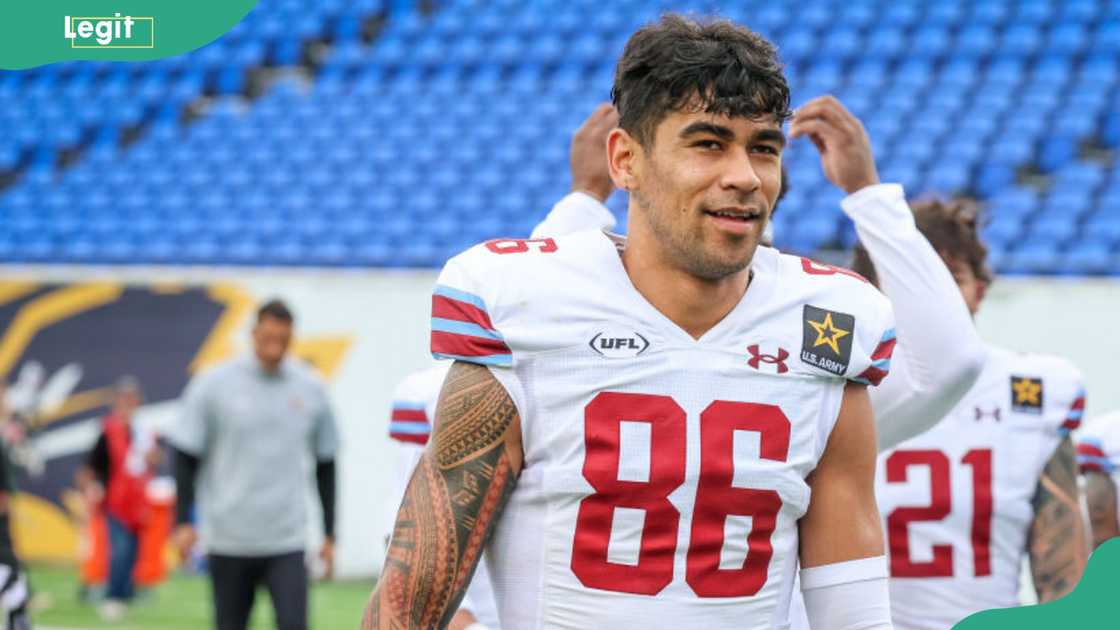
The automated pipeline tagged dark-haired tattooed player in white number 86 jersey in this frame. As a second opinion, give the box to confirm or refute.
[364,16,894,629]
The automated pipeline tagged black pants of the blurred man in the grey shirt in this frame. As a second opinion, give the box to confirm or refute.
[209,552,307,630]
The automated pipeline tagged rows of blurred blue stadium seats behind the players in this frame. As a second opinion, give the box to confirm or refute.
[0,0,1120,275]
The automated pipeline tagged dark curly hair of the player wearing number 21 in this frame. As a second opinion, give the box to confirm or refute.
[851,200,992,285]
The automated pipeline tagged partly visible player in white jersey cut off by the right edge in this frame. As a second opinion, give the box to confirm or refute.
[1077,411,1120,549]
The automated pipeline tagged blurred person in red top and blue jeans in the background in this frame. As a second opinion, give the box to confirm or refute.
[81,377,159,619]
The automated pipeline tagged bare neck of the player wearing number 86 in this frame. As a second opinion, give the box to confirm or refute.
[622,233,750,339]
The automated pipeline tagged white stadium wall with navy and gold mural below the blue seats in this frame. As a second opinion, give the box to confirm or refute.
[10,267,1120,576]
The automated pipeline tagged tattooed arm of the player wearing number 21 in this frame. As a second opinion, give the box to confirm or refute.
[1028,437,1089,603]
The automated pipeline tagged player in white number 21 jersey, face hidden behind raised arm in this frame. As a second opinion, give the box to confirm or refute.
[855,202,1085,630]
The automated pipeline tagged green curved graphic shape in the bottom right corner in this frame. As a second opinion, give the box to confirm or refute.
[953,538,1120,630]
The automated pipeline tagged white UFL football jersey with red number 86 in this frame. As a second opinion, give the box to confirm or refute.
[432,231,895,630]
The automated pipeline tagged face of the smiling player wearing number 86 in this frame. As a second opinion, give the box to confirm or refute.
[631,112,785,280]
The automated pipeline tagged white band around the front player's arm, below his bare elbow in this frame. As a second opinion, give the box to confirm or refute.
[801,556,892,630]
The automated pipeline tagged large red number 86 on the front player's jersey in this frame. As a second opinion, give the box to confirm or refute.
[571,392,790,597]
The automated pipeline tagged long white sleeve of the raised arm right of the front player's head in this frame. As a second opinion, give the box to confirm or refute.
[840,184,986,451]
